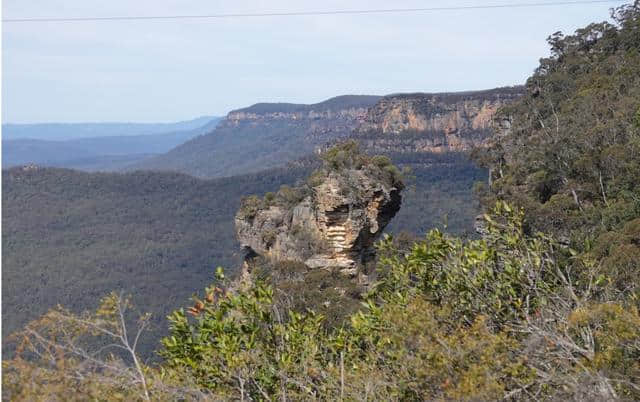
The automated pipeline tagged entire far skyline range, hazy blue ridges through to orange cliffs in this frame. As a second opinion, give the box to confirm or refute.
[3,86,523,178]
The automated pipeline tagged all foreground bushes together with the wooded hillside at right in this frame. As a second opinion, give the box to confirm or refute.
[3,1,640,401]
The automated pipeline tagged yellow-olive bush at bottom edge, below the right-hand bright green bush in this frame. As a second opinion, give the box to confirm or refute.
[347,302,534,400]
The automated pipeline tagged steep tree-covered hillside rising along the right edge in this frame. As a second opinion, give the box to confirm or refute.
[476,6,640,249]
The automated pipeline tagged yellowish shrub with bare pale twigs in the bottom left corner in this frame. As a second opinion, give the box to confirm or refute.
[3,293,168,401]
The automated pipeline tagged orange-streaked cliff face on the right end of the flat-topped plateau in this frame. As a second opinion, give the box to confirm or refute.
[357,87,524,152]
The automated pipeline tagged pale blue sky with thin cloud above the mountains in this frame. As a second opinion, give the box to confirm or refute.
[2,0,625,123]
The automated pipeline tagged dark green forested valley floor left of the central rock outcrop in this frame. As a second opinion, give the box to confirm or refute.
[2,163,305,354]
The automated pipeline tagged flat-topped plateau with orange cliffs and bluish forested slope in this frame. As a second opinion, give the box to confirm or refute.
[130,87,523,178]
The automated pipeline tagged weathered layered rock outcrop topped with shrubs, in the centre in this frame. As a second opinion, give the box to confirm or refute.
[235,151,402,274]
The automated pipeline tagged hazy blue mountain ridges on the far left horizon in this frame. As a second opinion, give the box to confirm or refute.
[2,117,220,171]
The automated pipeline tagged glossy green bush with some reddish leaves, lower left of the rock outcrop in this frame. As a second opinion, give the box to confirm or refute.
[162,276,322,399]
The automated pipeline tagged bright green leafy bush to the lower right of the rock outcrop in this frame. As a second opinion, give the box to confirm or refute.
[374,203,556,326]
